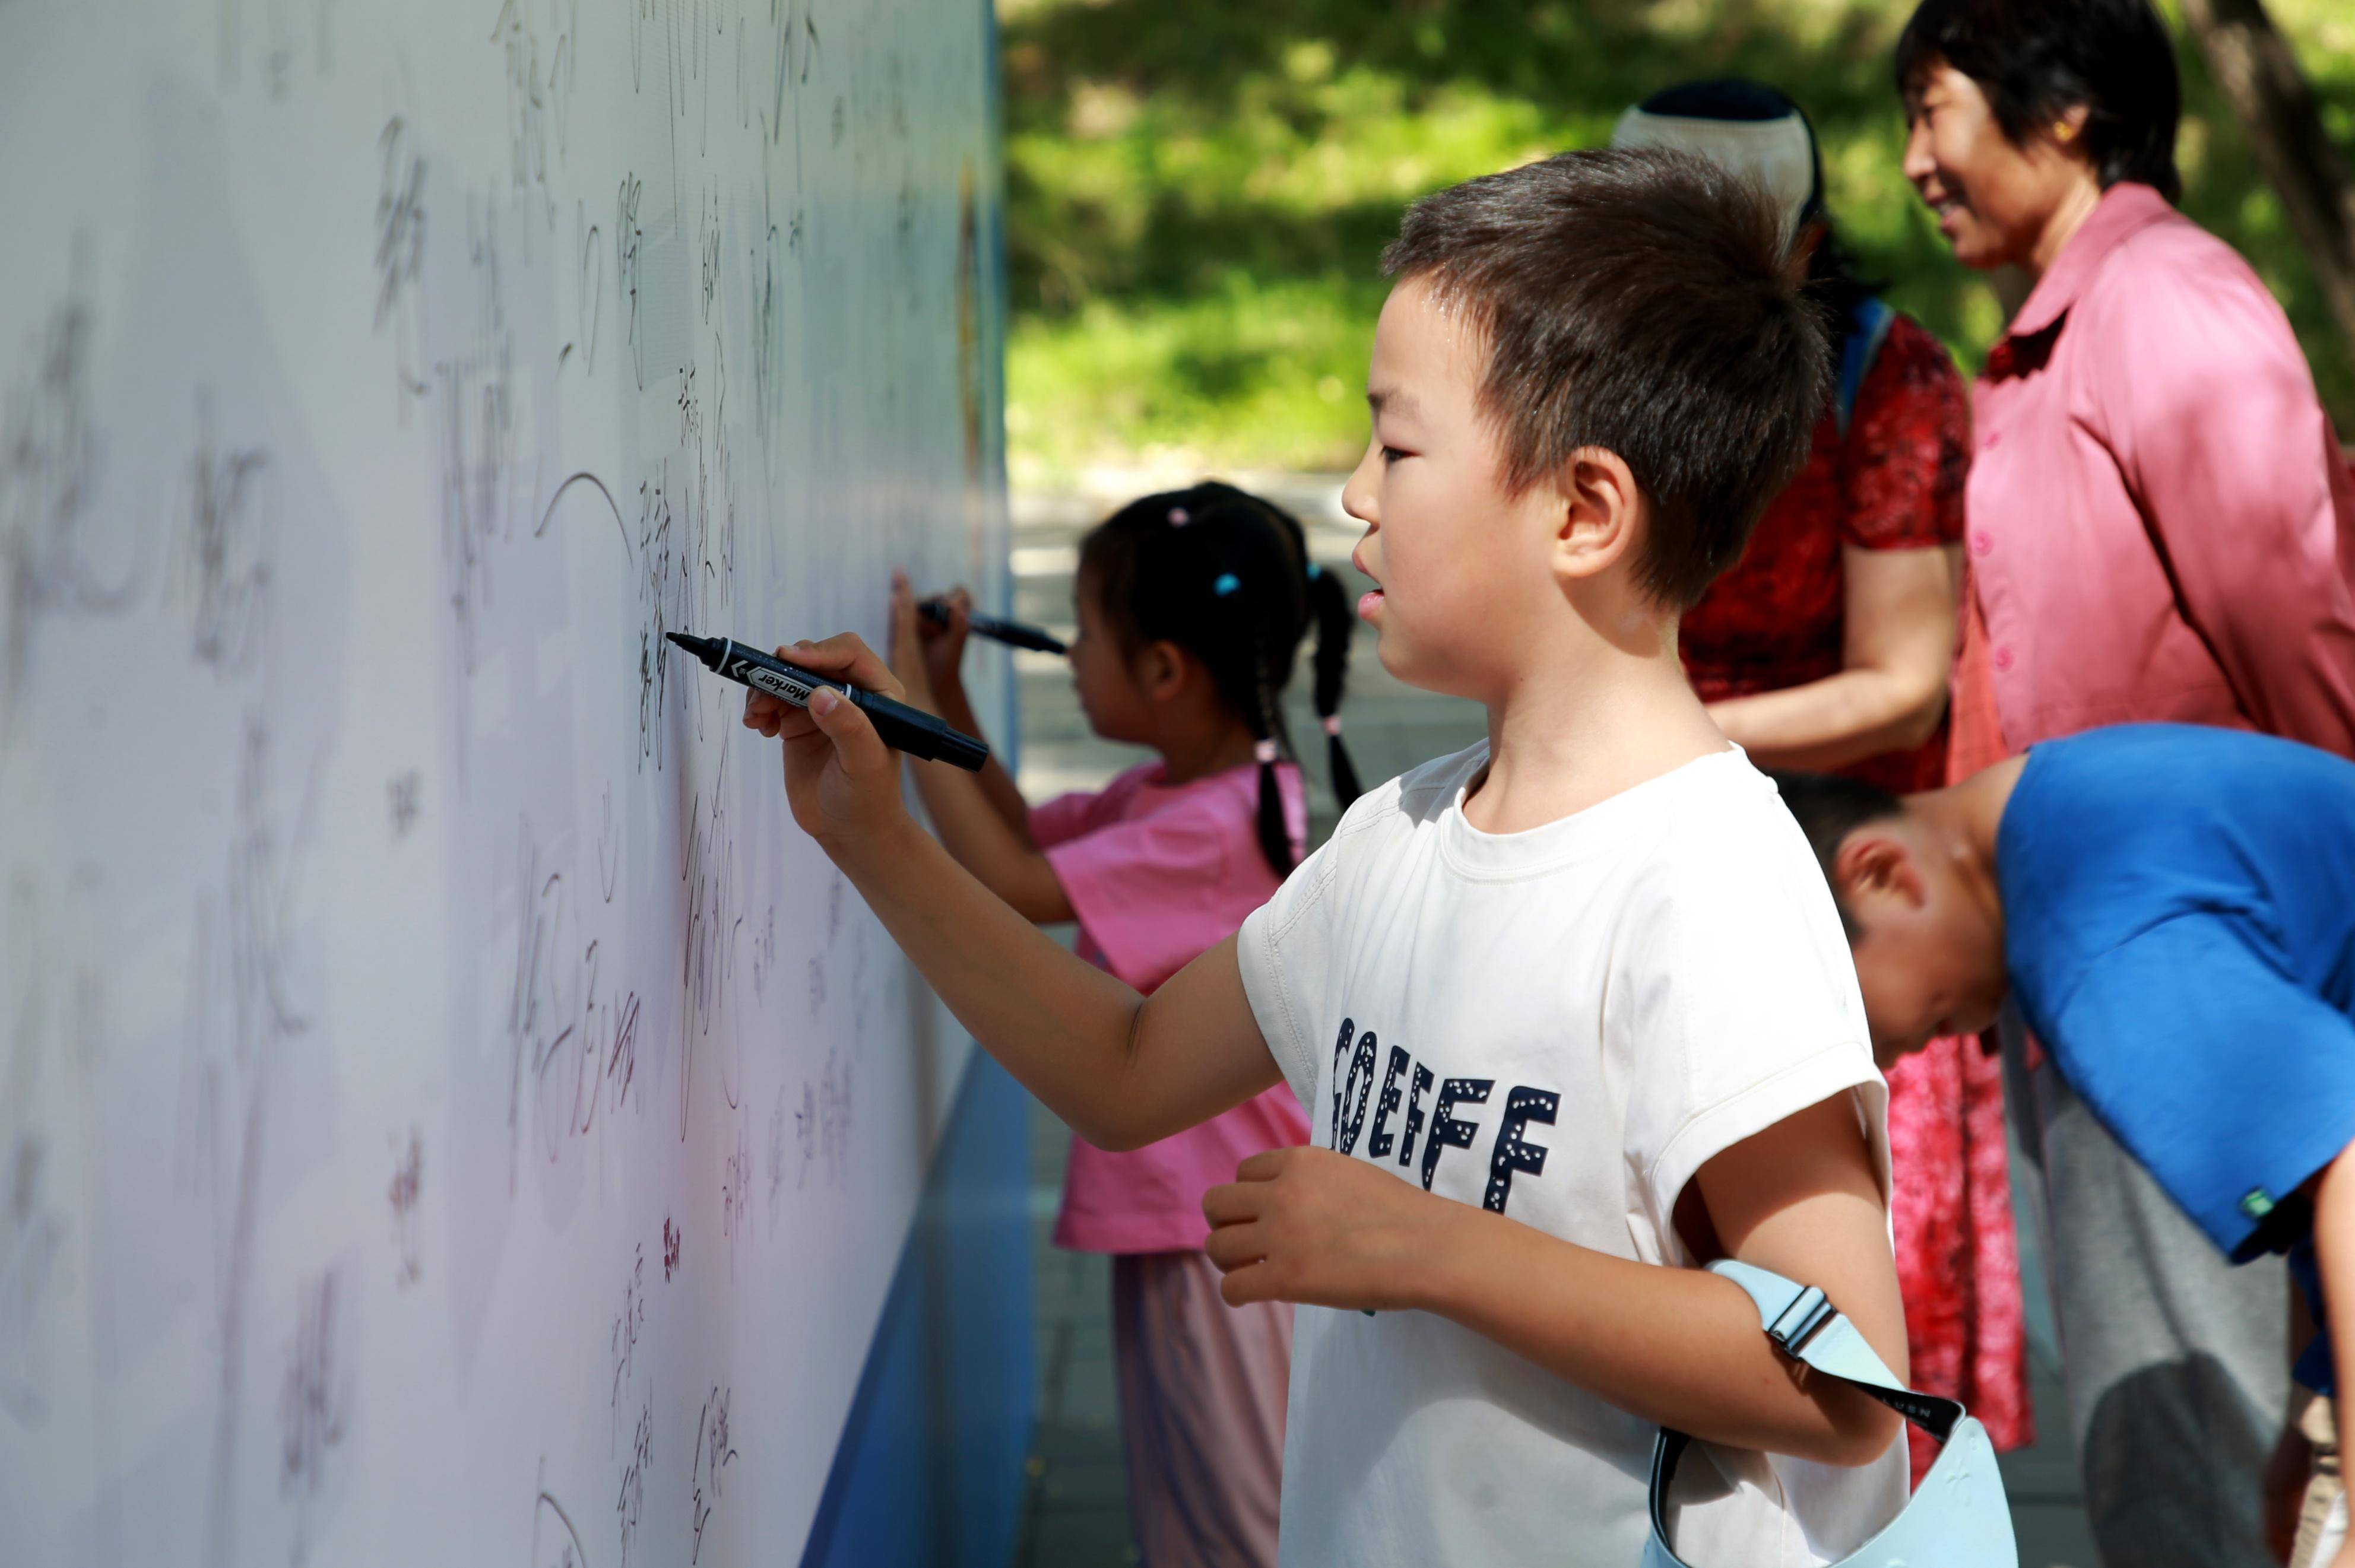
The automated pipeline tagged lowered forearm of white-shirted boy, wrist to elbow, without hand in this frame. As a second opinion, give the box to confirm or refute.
[1420,1205,1898,1464]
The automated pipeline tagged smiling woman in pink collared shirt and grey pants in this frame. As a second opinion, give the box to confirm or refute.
[1896,0,2355,1563]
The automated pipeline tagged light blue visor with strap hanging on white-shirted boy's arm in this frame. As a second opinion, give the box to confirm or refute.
[1644,1257,2018,1568]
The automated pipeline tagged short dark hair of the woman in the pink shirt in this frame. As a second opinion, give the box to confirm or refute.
[1896,0,2183,200]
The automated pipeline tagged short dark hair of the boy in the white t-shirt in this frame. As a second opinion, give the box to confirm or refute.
[1383,148,1830,610]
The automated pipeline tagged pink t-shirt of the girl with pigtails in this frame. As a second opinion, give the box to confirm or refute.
[1029,763,1310,1252]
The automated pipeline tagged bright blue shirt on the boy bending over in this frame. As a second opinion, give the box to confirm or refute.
[1995,725,2355,1387]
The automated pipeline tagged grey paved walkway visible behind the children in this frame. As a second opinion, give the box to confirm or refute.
[1015,473,2099,1568]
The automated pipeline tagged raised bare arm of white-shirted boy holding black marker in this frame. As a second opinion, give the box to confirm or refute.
[744,636,1276,1149]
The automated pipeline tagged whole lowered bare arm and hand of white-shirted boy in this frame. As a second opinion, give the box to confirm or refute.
[1203,1095,1905,1464]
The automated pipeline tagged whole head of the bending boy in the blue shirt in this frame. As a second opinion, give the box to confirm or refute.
[1776,772,2004,1067]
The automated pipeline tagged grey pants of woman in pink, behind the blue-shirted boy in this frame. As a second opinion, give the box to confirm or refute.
[2004,1015,2289,1568]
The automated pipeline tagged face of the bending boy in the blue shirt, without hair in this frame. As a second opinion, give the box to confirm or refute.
[1837,821,2004,1067]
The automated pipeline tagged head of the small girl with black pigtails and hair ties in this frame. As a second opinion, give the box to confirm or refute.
[1072,483,1359,876]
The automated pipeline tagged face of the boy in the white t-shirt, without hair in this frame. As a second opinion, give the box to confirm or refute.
[1342,278,1561,699]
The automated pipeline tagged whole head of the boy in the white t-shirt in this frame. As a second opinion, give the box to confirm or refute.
[1345,148,1830,697]
